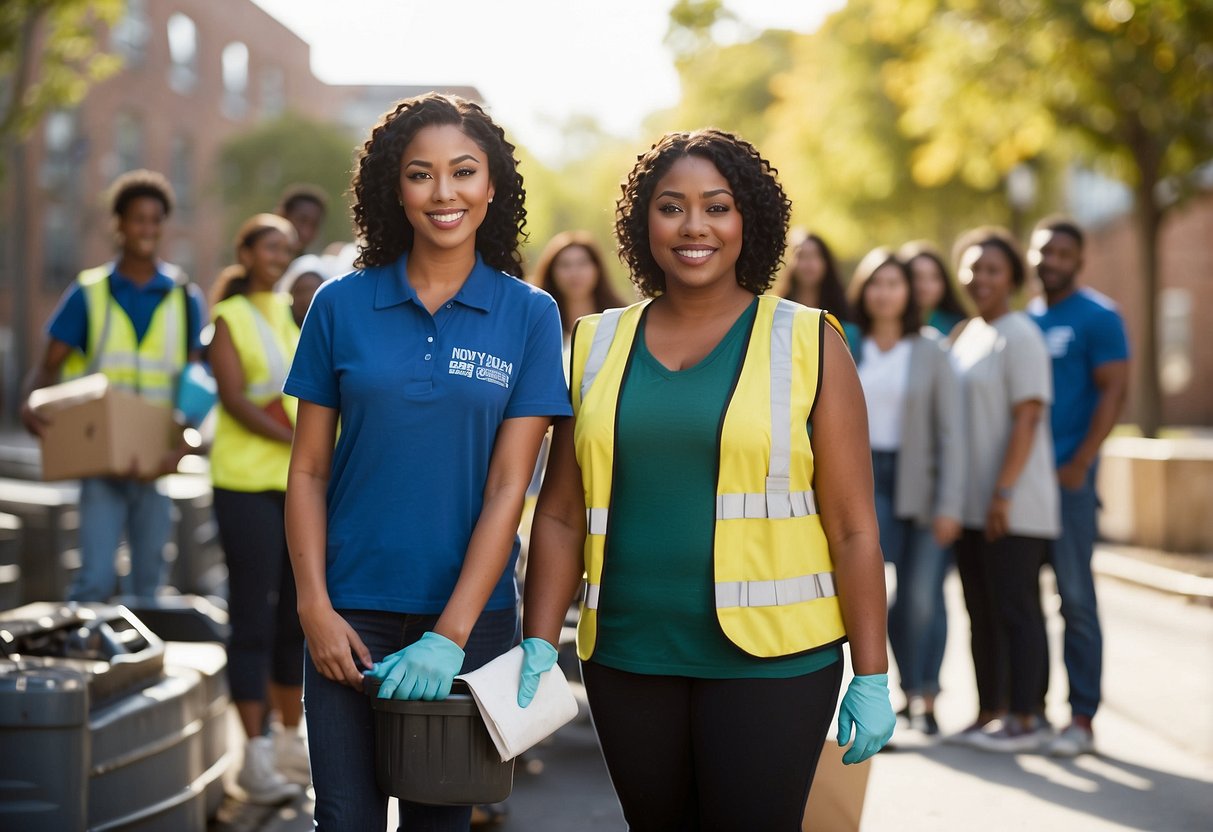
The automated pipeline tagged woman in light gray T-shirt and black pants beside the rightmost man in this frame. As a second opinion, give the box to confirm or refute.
[952,228,1060,752]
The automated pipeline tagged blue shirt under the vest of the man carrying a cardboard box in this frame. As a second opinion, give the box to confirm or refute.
[46,264,206,352]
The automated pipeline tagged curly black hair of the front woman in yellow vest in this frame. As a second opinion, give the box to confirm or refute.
[615,127,792,297]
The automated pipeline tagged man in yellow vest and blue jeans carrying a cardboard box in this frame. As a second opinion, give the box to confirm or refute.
[21,170,205,602]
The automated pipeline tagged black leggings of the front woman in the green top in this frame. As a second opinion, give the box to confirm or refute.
[581,661,842,832]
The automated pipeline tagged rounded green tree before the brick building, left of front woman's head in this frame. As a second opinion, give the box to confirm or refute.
[220,113,357,252]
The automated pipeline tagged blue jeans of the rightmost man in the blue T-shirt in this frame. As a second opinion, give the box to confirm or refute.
[1052,466,1104,717]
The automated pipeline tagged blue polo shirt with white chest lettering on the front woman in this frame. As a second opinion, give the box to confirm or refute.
[285,256,573,614]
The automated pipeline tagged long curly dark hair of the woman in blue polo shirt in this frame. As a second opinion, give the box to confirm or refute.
[352,92,526,278]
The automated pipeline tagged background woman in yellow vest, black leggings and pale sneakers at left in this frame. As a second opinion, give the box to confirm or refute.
[210,213,308,804]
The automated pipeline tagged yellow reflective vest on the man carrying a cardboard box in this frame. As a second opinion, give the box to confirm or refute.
[63,266,188,408]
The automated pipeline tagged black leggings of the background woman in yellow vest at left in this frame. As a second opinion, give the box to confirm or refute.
[215,489,303,702]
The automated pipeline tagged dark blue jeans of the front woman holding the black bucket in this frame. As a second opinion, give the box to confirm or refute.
[303,608,519,832]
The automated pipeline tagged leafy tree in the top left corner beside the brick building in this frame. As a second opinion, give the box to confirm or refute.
[0,0,125,154]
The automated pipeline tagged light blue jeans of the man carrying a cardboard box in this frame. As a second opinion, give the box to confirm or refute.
[68,477,172,602]
